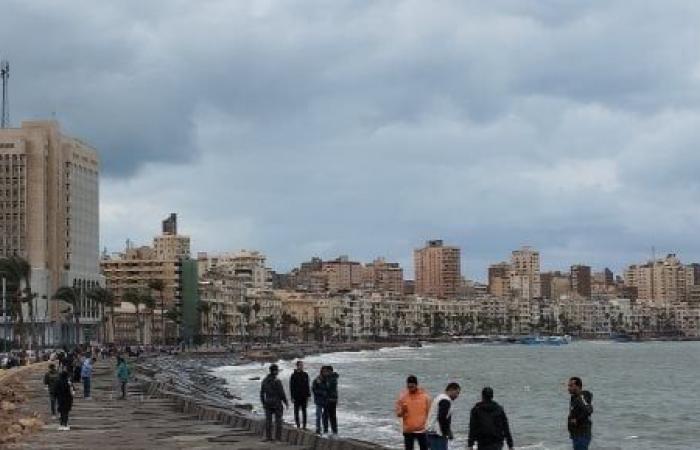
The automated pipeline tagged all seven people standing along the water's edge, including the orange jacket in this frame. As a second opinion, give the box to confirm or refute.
[260,361,593,450]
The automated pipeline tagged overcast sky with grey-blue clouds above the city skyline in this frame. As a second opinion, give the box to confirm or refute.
[0,0,700,279]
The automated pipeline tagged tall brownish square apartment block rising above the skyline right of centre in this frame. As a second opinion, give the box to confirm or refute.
[413,240,462,298]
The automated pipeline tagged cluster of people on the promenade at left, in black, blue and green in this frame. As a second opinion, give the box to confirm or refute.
[44,349,131,431]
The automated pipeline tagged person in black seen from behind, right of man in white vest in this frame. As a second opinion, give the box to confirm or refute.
[467,387,513,450]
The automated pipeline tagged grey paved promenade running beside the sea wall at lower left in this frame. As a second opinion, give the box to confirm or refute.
[7,361,303,450]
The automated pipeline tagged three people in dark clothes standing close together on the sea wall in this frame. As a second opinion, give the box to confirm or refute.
[260,361,339,441]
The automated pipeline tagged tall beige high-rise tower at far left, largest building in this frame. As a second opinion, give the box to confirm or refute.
[0,121,103,345]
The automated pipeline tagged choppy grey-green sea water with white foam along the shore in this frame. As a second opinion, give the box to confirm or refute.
[214,342,700,450]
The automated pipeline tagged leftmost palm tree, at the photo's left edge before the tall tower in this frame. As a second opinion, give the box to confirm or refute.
[0,256,34,350]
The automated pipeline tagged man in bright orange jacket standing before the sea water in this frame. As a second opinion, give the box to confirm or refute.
[396,375,430,450]
